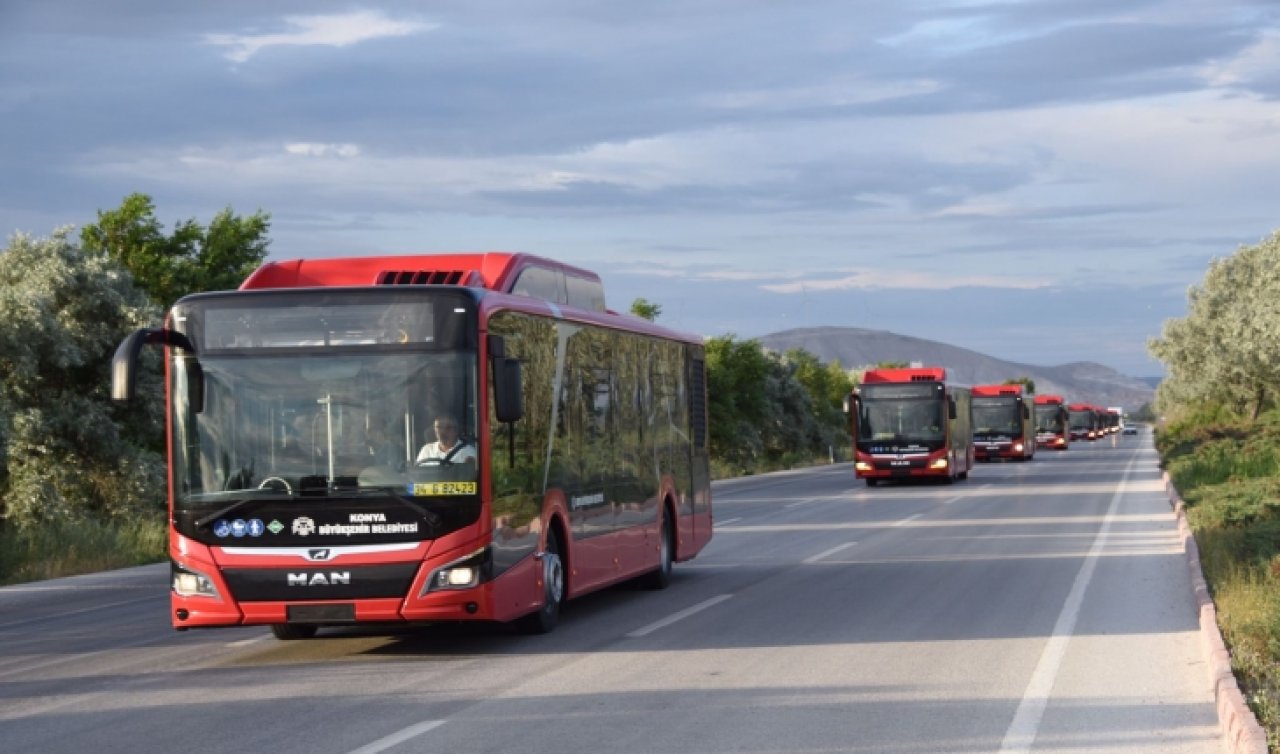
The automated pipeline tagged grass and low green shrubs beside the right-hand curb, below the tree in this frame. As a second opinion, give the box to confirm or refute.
[1156,415,1280,751]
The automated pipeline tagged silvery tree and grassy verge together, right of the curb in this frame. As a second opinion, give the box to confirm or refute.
[1148,227,1280,751]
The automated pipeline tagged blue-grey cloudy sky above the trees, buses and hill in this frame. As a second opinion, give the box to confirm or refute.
[0,0,1280,376]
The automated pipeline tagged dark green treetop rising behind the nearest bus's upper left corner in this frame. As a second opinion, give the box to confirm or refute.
[81,193,270,306]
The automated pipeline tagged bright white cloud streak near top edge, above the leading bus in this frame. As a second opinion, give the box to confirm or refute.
[205,10,438,63]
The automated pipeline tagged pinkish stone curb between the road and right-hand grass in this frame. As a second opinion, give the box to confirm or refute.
[1161,471,1267,754]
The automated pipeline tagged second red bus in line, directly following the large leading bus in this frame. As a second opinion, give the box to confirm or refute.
[847,366,974,486]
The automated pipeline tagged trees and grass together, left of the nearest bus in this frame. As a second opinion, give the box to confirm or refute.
[0,195,269,584]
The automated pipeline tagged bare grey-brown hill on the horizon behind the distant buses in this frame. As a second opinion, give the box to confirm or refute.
[755,328,1155,411]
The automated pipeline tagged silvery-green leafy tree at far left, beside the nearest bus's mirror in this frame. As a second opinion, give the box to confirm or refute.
[0,229,165,527]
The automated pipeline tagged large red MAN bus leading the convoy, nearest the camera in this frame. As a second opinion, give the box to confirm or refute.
[113,253,712,639]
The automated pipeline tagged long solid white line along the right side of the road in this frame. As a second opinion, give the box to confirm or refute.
[1000,456,1138,754]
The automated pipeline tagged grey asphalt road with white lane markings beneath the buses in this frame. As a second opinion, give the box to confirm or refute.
[0,435,1224,754]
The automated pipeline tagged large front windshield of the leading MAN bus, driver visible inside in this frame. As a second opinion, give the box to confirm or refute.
[169,291,480,536]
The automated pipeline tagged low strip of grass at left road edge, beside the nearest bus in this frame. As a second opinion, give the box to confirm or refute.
[0,520,168,584]
